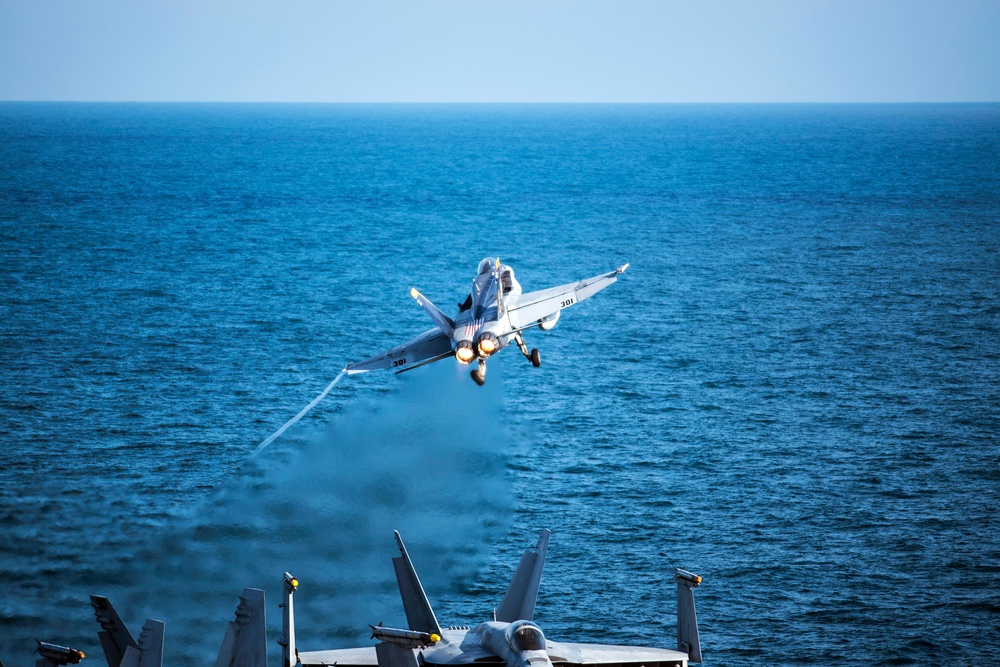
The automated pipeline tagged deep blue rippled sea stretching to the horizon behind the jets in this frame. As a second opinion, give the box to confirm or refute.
[0,104,1000,667]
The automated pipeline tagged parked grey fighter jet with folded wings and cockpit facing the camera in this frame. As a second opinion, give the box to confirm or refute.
[290,530,701,667]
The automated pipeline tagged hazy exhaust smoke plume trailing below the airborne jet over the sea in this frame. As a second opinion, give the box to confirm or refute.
[113,365,511,665]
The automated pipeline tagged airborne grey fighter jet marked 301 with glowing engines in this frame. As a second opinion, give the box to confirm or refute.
[346,257,628,386]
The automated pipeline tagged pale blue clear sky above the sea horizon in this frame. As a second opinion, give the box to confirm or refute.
[0,0,1000,103]
